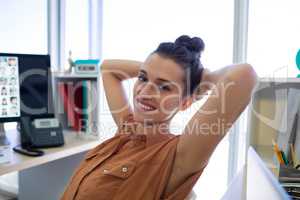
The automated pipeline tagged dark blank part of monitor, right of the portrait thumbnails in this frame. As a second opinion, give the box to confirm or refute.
[0,53,54,121]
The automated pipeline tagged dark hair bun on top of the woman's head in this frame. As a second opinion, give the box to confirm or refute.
[175,35,205,54]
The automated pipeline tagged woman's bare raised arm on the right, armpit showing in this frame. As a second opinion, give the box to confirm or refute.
[165,64,257,194]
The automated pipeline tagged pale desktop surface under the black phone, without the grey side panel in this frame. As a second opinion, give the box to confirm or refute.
[0,130,101,175]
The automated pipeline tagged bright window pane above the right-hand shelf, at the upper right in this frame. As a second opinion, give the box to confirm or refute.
[248,0,300,77]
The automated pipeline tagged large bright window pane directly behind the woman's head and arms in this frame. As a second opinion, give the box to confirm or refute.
[101,0,234,199]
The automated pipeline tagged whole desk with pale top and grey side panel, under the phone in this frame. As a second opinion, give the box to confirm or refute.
[0,131,102,200]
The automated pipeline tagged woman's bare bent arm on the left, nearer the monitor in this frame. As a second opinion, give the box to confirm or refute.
[101,60,142,128]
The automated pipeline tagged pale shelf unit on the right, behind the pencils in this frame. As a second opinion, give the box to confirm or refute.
[247,78,300,177]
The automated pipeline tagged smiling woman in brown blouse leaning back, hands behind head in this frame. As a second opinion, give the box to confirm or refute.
[62,35,256,200]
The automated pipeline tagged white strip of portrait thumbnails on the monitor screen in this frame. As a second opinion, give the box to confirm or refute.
[0,56,20,121]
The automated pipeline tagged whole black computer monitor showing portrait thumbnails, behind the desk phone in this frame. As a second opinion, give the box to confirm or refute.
[0,53,54,144]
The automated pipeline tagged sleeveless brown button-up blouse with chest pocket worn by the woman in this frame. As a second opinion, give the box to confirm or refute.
[61,115,203,200]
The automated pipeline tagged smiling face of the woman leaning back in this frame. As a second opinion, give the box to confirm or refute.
[133,54,192,124]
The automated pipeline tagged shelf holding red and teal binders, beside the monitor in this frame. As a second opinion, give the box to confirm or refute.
[54,73,100,138]
